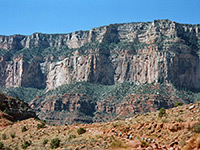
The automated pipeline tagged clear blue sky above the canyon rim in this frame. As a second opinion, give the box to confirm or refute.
[0,0,200,35]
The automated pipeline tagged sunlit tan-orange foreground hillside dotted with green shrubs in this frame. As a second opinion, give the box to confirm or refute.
[0,103,200,150]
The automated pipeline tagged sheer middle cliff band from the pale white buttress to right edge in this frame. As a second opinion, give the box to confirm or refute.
[47,45,200,89]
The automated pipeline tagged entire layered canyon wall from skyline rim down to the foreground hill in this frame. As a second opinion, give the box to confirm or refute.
[0,20,200,124]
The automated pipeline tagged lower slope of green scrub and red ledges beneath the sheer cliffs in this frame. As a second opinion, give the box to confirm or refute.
[29,82,195,124]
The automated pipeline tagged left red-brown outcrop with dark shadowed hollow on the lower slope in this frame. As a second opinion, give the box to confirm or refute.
[29,94,96,124]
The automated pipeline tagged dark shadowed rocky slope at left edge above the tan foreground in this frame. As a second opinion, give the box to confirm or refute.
[0,93,36,127]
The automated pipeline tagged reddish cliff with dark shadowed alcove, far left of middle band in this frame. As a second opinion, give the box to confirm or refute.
[0,56,45,88]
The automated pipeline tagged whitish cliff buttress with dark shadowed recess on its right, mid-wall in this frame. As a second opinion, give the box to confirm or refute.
[47,50,114,89]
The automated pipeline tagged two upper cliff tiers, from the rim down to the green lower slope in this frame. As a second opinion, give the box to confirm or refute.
[0,20,200,89]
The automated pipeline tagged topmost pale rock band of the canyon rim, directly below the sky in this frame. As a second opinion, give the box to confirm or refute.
[0,20,200,50]
